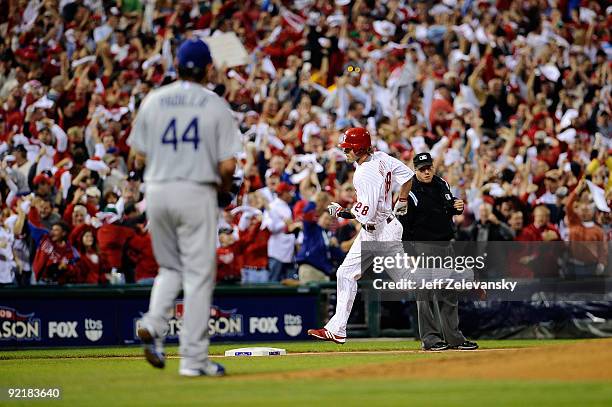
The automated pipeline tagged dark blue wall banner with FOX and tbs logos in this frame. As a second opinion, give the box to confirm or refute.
[0,294,318,349]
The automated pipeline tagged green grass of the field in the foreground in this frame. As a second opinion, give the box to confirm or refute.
[0,340,612,407]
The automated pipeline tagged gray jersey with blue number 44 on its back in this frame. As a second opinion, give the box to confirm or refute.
[128,81,241,183]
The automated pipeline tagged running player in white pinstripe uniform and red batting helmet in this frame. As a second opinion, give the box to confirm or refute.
[308,128,414,344]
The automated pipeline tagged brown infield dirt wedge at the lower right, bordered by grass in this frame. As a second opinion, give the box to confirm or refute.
[274,339,612,381]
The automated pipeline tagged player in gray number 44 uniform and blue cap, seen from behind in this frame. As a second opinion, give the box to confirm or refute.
[128,39,241,376]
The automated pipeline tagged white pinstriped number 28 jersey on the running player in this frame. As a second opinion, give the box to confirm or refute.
[351,151,414,225]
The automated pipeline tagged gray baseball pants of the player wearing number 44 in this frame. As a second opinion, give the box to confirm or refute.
[143,181,218,369]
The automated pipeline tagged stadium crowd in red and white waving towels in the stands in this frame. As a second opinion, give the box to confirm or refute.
[0,0,612,285]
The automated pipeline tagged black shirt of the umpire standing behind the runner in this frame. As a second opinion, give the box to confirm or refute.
[398,175,461,242]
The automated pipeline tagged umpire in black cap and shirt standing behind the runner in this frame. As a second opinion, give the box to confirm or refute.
[399,153,478,351]
